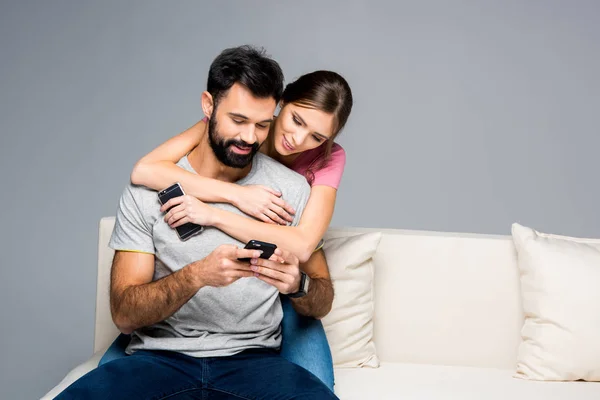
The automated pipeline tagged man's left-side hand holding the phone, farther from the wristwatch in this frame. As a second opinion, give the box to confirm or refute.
[191,244,260,287]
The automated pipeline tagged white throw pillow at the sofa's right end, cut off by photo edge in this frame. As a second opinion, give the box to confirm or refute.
[512,224,600,381]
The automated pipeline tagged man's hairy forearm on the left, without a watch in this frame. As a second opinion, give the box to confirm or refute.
[111,265,200,333]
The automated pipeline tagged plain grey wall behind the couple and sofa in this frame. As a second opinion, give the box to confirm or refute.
[0,0,600,399]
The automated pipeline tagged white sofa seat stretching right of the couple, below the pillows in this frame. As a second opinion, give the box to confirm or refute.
[335,362,600,400]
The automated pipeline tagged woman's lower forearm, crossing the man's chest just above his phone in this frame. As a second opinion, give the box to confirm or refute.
[212,207,320,262]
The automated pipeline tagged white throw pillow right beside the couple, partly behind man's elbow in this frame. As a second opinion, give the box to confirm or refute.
[322,232,381,368]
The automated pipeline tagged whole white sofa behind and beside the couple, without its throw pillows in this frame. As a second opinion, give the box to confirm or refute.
[44,217,600,400]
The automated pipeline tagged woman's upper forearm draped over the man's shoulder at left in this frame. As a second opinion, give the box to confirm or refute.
[131,161,238,204]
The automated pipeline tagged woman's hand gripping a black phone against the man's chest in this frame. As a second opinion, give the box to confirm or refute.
[160,195,214,228]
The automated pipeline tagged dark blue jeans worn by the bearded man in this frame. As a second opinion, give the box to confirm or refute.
[56,349,337,400]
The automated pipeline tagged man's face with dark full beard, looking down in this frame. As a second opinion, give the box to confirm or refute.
[208,84,276,168]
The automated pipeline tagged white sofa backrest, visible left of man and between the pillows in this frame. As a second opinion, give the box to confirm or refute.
[94,217,523,368]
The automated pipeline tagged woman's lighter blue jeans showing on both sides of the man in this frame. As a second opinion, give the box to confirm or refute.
[98,296,334,391]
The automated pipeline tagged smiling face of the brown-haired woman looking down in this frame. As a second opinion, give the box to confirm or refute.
[274,103,334,156]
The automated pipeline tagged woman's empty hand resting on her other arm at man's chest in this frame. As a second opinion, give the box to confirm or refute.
[234,185,296,225]
